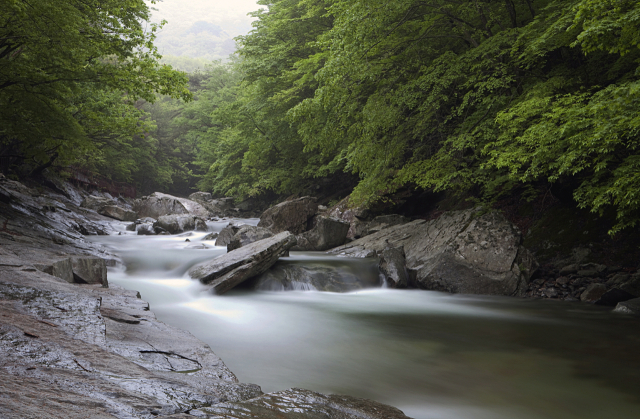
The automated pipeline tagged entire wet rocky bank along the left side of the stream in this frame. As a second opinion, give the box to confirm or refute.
[0,177,406,419]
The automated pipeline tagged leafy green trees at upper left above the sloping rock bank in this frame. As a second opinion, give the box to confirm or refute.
[0,0,190,186]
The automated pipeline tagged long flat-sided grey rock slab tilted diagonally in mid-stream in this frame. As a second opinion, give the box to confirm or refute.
[189,231,296,294]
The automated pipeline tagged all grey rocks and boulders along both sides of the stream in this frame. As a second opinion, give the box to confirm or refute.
[0,172,640,419]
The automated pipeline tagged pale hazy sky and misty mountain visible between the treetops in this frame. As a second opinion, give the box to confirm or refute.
[152,0,260,61]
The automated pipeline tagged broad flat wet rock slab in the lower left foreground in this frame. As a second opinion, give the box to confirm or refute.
[0,268,262,418]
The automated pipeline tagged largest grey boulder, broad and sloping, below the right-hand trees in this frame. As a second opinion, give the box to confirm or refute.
[331,210,537,296]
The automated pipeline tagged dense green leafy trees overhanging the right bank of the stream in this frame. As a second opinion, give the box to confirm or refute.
[174,0,640,231]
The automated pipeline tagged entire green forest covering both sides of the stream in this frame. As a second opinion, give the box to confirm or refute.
[0,0,640,235]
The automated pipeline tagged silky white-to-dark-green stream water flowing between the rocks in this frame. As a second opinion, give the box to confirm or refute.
[92,219,640,419]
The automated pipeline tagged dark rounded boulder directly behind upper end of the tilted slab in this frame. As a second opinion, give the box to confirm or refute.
[258,196,318,234]
